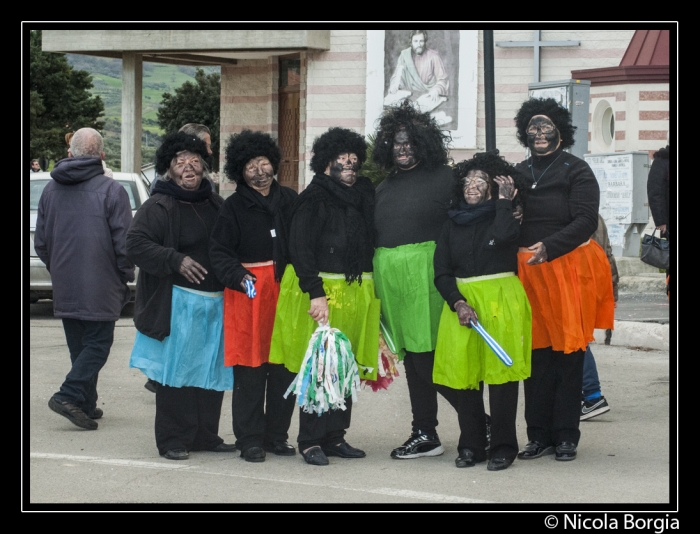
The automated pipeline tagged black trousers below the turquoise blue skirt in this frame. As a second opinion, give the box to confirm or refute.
[155,383,224,455]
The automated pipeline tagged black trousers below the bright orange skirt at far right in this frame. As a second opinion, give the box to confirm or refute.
[523,347,585,445]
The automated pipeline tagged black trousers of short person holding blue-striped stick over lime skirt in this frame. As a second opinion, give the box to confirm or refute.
[436,382,520,462]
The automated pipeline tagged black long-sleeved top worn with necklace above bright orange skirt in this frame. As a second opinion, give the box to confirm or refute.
[516,149,600,261]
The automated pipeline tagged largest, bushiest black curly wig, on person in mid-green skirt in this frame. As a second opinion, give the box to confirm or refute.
[372,100,452,170]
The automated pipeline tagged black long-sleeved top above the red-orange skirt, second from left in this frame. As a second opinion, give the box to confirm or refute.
[209,182,297,292]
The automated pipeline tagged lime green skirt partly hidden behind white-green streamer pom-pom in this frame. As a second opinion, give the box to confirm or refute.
[269,265,381,380]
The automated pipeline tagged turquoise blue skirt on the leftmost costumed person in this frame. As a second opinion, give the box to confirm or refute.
[129,286,233,391]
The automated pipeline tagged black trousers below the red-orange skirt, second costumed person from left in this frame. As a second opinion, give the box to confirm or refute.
[231,363,295,451]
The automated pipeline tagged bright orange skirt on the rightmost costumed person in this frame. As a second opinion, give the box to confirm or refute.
[518,240,615,354]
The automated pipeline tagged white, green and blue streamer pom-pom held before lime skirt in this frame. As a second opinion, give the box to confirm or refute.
[284,324,360,415]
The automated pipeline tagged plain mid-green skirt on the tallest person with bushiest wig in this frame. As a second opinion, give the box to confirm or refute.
[374,241,445,360]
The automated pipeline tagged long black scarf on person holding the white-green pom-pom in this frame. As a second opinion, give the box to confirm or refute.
[309,174,374,284]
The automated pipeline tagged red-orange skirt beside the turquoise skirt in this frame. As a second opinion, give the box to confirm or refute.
[224,261,280,367]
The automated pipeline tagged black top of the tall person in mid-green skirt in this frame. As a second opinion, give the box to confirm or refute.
[374,164,453,248]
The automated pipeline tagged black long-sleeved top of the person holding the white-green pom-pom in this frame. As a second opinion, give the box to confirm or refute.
[289,174,374,299]
